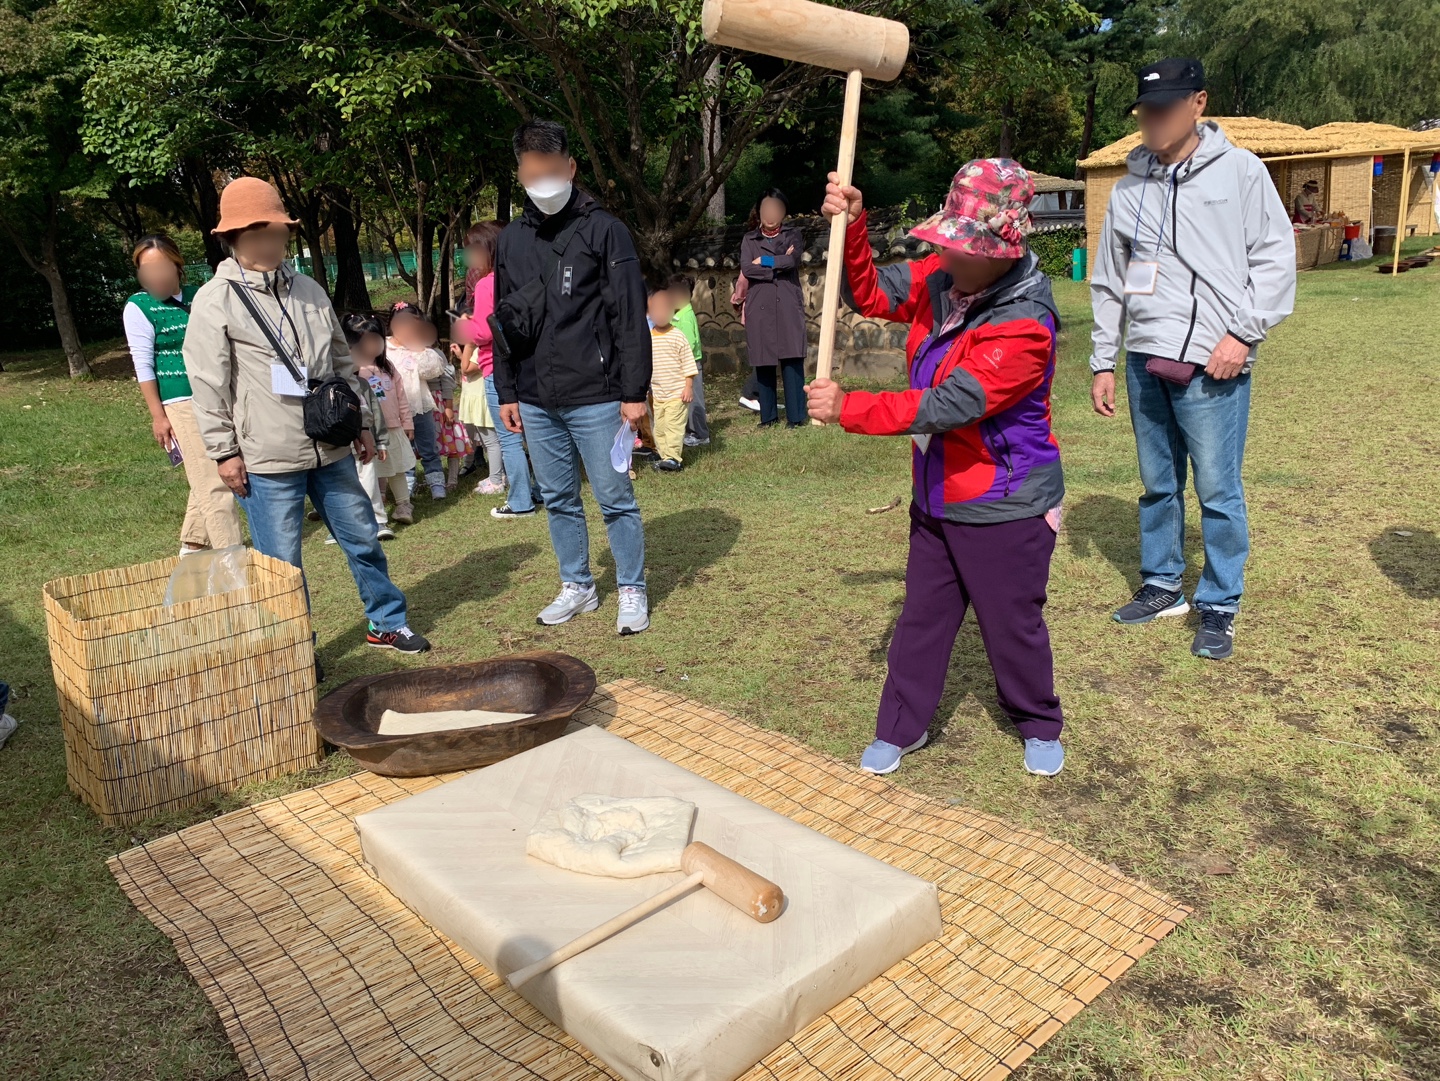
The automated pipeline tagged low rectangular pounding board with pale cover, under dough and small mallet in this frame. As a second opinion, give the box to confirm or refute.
[356,728,940,1081]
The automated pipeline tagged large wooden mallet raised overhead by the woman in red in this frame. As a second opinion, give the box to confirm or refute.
[701,0,910,379]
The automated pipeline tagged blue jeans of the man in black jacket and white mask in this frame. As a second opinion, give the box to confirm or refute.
[520,402,645,589]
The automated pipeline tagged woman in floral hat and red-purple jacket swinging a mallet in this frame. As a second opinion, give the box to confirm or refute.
[808,158,1064,776]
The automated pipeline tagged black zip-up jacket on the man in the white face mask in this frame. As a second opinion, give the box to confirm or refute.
[495,189,651,409]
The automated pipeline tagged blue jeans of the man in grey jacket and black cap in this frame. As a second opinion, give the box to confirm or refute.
[1125,353,1250,612]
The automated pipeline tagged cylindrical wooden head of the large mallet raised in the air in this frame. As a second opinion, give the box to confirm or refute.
[700,0,910,82]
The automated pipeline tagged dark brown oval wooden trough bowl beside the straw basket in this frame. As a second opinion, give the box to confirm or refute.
[312,652,595,777]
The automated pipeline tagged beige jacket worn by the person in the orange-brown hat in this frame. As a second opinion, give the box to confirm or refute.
[184,259,370,474]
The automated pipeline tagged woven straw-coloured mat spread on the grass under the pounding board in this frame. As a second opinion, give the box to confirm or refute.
[109,681,1188,1081]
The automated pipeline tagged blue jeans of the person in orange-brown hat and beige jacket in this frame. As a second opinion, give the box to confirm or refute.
[240,458,405,630]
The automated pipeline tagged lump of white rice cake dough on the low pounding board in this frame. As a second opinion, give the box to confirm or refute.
[526,792,696,878]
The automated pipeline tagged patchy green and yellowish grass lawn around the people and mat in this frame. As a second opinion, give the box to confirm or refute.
[0,244,1440,1081]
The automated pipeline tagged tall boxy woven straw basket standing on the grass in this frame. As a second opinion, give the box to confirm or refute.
[45,550,321,826]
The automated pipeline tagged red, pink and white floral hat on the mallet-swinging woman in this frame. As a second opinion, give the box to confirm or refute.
[910,158,1035,259]
